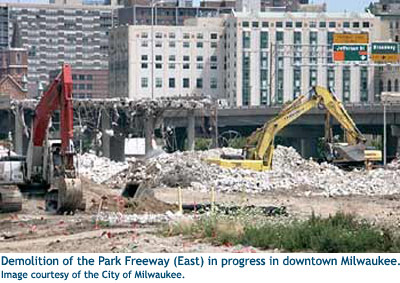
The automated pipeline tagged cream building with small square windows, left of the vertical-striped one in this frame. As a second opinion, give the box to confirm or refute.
[109,18,225,99]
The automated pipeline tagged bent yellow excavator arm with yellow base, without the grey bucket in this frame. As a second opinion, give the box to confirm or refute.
[208,86,378,171]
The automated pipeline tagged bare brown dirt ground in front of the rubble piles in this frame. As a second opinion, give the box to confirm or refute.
[0,181,400,252]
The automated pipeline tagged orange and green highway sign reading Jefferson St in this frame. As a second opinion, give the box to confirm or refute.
[333,44,368,62]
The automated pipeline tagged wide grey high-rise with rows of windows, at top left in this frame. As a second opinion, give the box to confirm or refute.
[0,0,117,96]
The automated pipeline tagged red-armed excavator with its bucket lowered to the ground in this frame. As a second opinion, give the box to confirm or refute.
[0,65,84,213]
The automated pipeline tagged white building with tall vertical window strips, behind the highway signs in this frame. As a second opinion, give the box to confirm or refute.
[226,10,380,106]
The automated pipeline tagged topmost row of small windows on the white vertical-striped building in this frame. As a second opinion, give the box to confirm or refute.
[242,21,371,28]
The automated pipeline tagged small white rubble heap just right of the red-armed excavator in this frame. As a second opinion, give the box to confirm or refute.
[78,153,130,184]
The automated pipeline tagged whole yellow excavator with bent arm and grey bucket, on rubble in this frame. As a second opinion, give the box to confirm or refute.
[207,86,382,171]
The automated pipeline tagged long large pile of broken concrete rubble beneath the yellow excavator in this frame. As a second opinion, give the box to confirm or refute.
[107,146,400,197]
